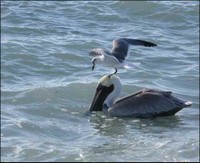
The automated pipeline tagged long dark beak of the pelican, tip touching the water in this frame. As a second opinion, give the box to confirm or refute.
[89,84,114,112]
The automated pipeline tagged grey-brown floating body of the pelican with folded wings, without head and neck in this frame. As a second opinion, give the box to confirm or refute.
[109,89,191,118]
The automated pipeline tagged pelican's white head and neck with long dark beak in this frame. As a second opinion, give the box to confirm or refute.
[89,73,121,111]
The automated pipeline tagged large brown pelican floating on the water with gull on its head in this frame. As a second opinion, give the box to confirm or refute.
[88,73,192,118]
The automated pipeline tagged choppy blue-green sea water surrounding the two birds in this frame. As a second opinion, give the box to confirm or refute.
[1,1,199,161]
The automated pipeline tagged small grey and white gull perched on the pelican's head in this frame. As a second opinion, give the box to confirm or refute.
[89,38,157,72]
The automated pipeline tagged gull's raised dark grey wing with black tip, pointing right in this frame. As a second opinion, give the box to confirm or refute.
[111,38,157,62]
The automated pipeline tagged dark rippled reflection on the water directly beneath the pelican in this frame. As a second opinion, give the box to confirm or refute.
[90,112,181,137]
